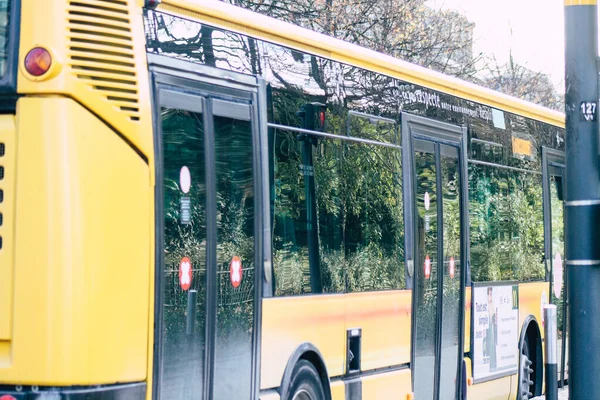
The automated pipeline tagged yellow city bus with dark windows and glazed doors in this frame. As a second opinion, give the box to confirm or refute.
[0,0,566,400]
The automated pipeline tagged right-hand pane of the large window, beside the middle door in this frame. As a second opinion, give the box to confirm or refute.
[344,143,404,292]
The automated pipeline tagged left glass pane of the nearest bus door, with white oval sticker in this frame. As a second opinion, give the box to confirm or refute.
[160,108,206,399]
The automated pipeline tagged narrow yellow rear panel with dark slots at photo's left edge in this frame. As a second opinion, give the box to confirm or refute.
[0,115,17,344]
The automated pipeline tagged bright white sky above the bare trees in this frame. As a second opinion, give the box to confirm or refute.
[427,0,565,92]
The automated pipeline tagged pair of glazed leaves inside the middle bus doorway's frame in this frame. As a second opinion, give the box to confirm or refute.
[413,139,462,400]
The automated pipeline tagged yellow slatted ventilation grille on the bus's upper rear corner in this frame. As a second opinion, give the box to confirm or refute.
[68,0,140,121]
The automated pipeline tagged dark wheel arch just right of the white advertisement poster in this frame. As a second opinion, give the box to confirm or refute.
[517,315,544,397]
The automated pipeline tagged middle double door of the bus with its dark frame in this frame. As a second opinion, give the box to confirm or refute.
[402,114,467,400]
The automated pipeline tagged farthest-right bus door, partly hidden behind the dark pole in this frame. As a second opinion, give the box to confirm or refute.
[542,147,568,386]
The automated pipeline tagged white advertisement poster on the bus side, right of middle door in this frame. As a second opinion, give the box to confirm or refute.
[473,283,519,381]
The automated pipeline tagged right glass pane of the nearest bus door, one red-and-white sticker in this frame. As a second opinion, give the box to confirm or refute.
[213,117,255,400]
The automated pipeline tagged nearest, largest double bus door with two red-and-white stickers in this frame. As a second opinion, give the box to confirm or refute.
[149,55,264,400]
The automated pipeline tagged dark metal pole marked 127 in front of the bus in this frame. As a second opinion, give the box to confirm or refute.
[565,0,600,400]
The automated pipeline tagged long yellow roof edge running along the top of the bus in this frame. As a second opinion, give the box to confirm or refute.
[159,0,565,128]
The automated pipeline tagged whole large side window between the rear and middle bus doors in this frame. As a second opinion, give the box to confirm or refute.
[272,126,404,296]
